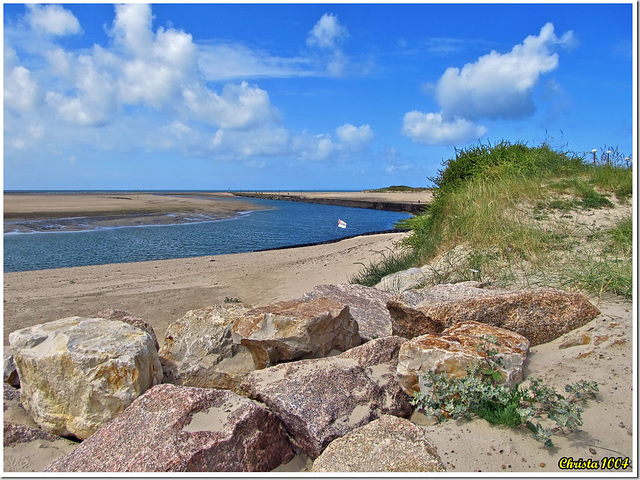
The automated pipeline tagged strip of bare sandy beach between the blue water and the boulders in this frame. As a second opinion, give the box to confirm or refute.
[4,233,403,345]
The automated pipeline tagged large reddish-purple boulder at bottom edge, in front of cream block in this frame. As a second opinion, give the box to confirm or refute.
[45,384,294,472]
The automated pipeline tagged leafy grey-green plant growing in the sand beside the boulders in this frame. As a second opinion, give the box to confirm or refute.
[412,336,598,447]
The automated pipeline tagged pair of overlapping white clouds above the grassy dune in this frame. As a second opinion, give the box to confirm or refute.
[402,23,575,145]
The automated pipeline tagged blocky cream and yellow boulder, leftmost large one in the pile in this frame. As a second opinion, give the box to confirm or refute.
[9,317,162,439]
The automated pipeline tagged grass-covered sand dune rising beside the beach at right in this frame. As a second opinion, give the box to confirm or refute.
[351,137,633,298]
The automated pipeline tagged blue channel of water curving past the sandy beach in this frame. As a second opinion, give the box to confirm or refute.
[4,199,410,272]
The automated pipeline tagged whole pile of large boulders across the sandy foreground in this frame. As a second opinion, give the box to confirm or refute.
[5,278,597,472]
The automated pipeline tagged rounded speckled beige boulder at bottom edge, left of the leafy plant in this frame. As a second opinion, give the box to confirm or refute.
[311,415,445,472]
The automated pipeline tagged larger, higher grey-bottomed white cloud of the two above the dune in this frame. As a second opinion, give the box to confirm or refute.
[436,23,573,120]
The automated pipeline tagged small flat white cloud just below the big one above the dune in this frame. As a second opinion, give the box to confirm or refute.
[402,111,487,145]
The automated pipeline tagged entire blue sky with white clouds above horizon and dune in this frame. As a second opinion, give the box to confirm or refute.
[4,3,636,190]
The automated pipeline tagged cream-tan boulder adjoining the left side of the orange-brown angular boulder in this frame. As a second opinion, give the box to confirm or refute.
[158,305,255,389]
